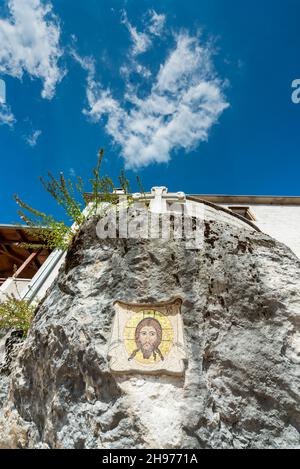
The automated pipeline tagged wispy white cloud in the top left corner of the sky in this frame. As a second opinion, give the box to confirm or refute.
[0,0,65,99]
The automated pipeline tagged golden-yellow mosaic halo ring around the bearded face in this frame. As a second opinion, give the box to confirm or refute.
[124,309,174,365]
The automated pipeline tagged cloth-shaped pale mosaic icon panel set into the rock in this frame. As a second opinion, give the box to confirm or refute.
[108,298,186,376]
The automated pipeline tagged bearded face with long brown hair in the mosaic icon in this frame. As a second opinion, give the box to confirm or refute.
[128,318,164,360]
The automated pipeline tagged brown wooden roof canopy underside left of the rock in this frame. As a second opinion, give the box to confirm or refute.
[0,225,50,286]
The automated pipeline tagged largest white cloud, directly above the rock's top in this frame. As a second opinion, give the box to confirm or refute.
[84,33,229,169]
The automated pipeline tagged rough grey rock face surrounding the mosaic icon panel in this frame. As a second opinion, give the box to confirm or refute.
[0,211,300,448]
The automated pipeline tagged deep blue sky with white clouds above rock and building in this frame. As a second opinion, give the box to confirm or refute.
[0,0,300,223]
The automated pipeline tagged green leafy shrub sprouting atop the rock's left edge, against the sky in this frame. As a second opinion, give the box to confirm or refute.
[14,149,132,249]
